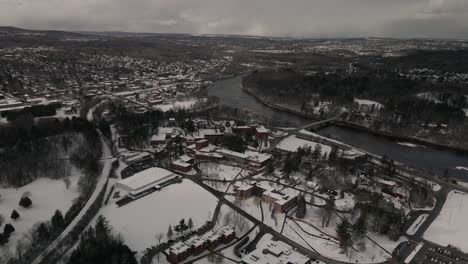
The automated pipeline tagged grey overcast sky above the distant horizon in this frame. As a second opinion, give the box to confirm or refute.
[0,0,468,39]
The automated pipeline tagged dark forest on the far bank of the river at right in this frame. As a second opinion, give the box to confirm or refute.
[243,69,468,123]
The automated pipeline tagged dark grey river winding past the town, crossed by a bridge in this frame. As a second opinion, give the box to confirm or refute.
[208,76,468,181]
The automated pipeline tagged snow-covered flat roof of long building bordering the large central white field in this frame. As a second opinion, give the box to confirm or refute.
[118,167,173,190]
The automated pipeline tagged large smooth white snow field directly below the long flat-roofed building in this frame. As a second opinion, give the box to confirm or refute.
[98,180,217,256]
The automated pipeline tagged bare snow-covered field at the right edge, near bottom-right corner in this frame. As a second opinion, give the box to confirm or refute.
[424,191,468,252]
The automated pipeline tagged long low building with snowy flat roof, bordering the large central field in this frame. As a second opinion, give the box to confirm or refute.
[116,167,178,198]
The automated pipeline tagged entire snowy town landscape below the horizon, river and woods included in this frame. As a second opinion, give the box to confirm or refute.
[0,24,468,264]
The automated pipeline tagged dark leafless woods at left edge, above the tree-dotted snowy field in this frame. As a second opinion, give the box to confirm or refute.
[0,118,101,187]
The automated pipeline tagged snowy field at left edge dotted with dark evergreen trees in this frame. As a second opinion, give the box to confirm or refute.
[0,172,80,252]
